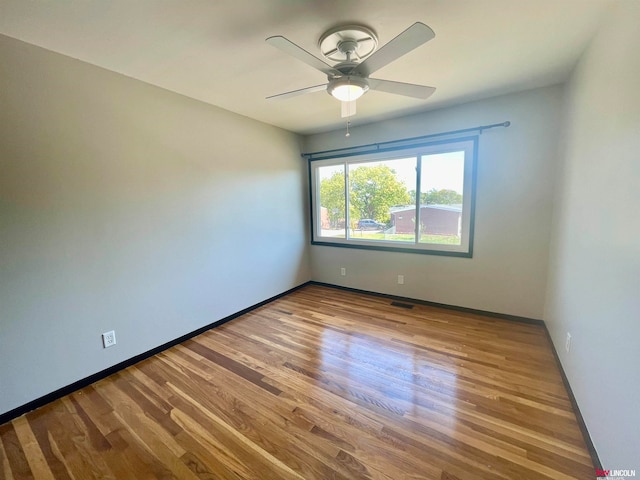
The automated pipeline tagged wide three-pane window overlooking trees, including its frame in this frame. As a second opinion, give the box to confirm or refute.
[309,137,477,257]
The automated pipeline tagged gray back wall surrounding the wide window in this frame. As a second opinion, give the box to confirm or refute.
[305,87,563,319]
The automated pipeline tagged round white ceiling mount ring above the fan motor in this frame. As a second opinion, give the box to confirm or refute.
[318,25,378,62]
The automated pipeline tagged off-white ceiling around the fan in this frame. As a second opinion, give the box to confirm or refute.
[0,0,615,134]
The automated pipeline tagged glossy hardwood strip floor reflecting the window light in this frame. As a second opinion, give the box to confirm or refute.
[0,285,595,480]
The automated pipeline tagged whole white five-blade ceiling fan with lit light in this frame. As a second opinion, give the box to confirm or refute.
[266,22,435,117]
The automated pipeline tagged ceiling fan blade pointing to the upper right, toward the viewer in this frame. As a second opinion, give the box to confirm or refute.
[353,22,436,76]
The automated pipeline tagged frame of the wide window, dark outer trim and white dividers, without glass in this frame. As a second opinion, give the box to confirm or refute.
[308,135,479,258]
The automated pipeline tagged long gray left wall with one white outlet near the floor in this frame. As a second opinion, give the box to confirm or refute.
[0,37,310,413]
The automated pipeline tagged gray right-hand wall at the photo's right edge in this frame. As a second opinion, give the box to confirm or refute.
[545,0,640,474]
